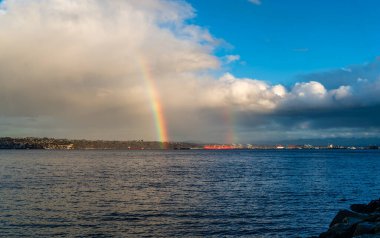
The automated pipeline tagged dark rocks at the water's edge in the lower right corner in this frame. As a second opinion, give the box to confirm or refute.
[319,199,380,238]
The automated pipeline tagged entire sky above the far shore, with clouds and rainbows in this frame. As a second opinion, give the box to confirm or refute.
[0,0,380,144]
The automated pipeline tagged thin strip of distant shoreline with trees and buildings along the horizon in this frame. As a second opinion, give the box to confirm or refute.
[0,137,379,150]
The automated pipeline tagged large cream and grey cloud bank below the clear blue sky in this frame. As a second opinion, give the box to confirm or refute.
[0,0,380,142]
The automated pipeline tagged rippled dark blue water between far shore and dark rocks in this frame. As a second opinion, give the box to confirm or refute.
[0,150,380,237]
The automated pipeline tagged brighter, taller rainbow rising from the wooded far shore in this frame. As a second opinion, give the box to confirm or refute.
[140,59,169,149]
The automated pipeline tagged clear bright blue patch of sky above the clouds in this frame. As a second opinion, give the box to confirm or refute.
[188,0,380,84]
